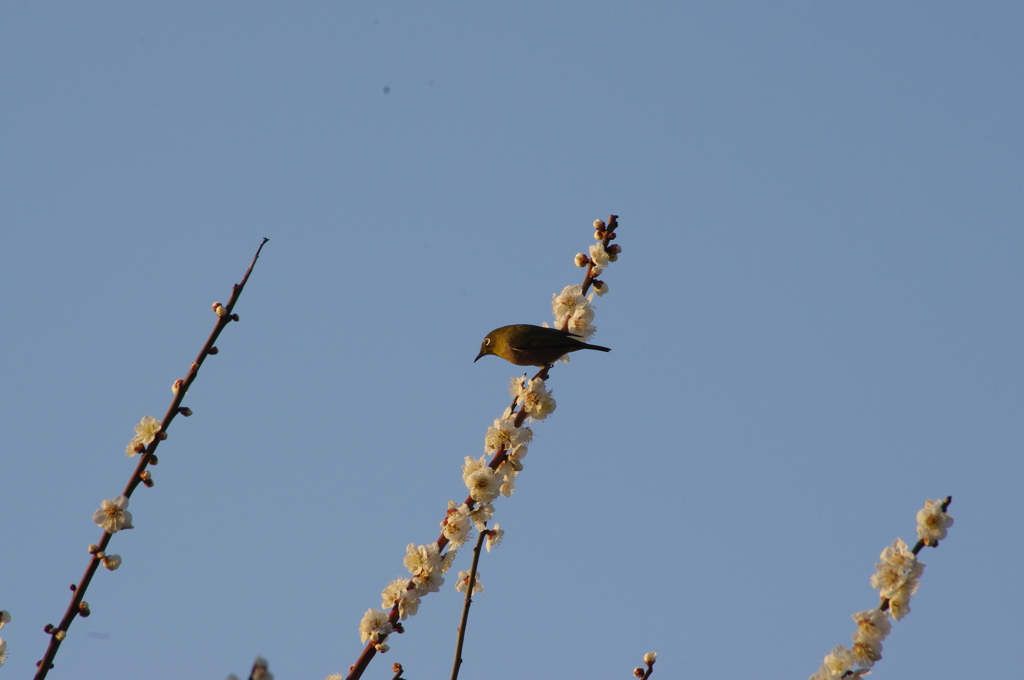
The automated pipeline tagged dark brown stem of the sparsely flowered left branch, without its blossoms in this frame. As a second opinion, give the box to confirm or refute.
[36,239,269,680]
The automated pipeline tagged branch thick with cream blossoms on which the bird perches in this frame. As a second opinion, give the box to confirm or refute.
[347,215,622,680]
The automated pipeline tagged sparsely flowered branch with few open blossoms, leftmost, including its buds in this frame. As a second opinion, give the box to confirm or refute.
[36,239,268,680]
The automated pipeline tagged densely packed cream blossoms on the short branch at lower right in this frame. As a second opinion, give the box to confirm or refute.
[810,501,953,680]
